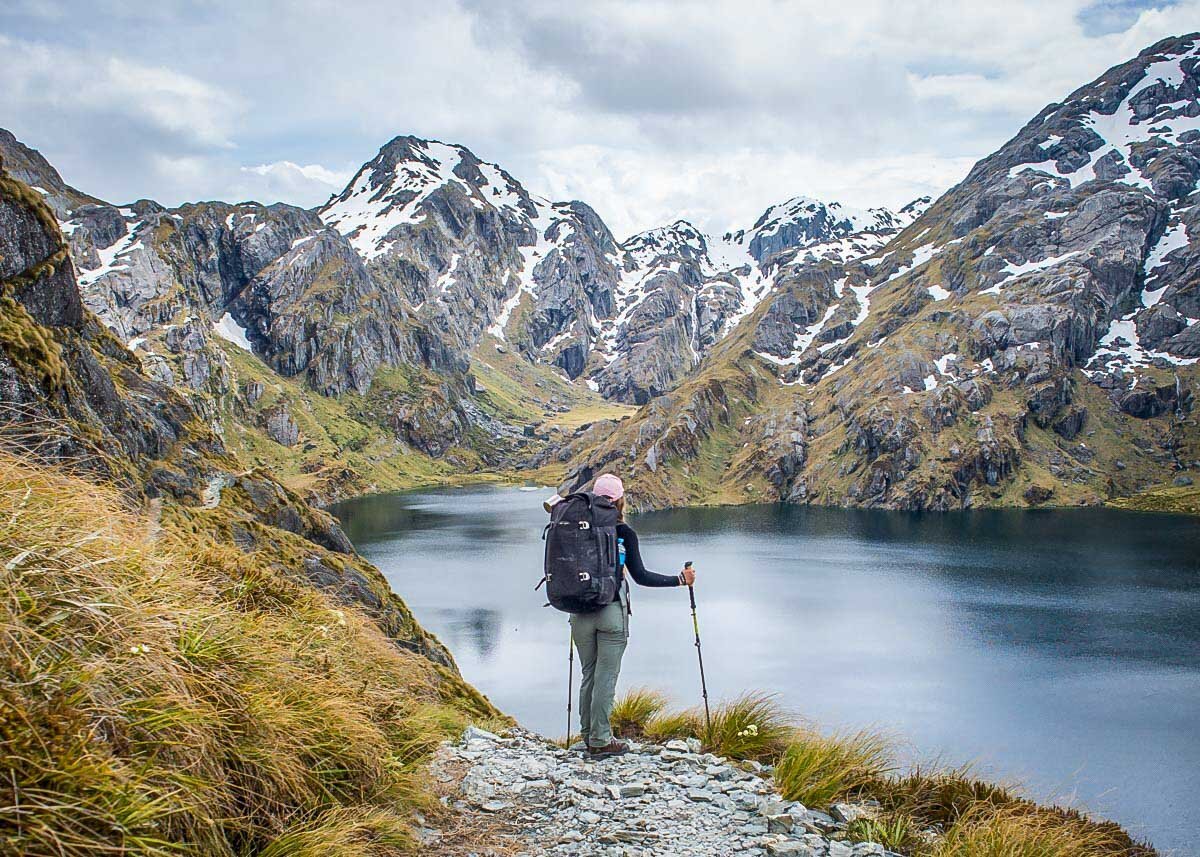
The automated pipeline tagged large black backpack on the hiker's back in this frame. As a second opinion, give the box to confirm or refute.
[538,491,620,613]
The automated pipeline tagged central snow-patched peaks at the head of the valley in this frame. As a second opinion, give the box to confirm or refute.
[319,130,911,403]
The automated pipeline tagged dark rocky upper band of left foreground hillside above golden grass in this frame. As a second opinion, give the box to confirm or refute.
[0,157,468,670]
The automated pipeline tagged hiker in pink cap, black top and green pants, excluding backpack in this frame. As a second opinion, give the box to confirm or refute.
[547,473,696,757]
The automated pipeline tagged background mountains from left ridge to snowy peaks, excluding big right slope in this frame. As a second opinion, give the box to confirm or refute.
[0,125,911,501]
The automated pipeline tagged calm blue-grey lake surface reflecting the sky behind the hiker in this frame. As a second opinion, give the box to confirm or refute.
[332,489,1200,855]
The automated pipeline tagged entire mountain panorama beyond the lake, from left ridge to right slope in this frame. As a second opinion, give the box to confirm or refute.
[0,34,1200,511]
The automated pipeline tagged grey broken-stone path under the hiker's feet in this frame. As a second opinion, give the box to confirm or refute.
[432,727,892,857]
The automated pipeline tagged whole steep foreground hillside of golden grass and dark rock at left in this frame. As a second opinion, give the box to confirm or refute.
[0,143,499,857]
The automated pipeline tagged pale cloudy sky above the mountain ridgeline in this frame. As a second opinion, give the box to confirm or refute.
[0,0,1200,236]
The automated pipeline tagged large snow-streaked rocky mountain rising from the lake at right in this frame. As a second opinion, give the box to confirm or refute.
[559,35,1200,509]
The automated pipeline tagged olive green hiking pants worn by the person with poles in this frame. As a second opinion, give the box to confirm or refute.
[571,589,629,747]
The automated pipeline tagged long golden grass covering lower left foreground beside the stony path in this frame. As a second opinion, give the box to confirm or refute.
[0,453,492,857]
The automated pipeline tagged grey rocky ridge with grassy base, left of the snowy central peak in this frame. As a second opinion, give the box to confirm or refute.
[0,134,573,501]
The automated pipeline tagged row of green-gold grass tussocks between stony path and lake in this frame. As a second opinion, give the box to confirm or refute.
[612,688,1156,857]
